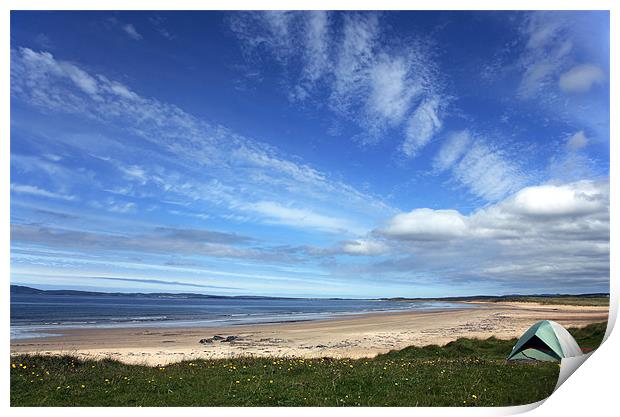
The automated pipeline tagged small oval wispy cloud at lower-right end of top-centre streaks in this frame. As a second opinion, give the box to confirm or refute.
[402,97,442,158]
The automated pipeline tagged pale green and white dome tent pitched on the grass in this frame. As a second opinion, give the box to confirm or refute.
[508,320,583,361]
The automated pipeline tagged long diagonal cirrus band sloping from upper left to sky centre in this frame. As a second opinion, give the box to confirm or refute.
[11,48,392,233]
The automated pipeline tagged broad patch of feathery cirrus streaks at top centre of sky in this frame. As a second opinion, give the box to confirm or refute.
[231,12,448,158]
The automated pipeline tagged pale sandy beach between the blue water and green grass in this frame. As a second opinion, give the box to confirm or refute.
[11,303,608,365]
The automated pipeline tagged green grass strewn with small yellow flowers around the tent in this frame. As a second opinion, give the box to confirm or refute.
[11,323,605,406]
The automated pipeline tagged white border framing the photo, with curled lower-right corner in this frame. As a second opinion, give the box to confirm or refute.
[0,0,620,417]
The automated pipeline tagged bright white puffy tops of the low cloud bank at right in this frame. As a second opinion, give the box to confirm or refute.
[378,181,609,241]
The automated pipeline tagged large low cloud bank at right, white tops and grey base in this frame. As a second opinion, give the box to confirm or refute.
[370,181,610,292]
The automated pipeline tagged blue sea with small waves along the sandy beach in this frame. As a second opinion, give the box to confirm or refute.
[11,294,470,339]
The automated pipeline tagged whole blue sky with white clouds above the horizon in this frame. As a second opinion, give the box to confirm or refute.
[11,12,610,297]
